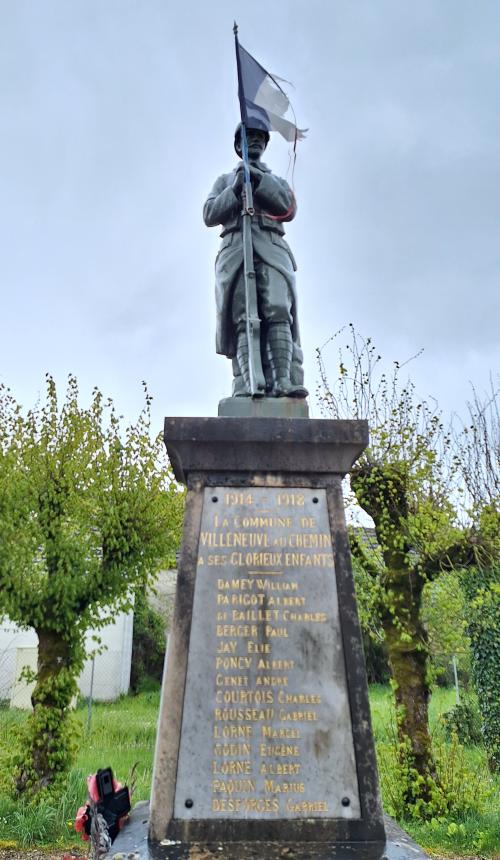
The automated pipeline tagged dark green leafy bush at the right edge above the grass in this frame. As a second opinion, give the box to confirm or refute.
[462,564,500,771]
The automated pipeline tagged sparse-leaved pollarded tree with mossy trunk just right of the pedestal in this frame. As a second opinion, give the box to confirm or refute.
[318,326,463,810]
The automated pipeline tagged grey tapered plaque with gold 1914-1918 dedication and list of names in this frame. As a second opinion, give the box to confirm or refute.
[174,487,360,819]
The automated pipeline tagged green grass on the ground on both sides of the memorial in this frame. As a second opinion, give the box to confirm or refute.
[0,685,500,857]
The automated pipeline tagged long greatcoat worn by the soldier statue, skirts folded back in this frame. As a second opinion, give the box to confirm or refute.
[203,161,300,358]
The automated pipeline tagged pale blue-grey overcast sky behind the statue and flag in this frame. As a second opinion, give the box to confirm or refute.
[0,0,500,428]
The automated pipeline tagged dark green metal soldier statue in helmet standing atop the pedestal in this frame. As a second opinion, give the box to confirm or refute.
[203,123,308,398]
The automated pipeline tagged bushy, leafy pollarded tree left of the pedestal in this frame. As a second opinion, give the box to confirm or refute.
[0,376,183,795]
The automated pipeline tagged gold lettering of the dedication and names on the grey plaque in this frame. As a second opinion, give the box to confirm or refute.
[200,490,334,818]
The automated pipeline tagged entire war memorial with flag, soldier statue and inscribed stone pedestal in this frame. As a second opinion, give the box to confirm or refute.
[114,26,424,860]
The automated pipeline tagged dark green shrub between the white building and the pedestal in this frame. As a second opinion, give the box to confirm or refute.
[130,590,166,693]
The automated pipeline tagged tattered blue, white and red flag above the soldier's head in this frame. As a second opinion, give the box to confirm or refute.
[235,29,307,143]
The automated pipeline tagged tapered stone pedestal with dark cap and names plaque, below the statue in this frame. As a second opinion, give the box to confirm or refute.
[149,417,385,860]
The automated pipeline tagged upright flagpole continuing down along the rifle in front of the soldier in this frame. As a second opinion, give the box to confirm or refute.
[233,21,266,397]
